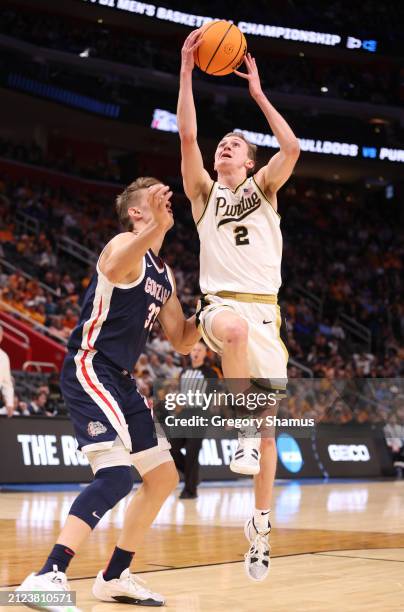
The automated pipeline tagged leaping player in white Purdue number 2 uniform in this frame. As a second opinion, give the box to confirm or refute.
[177,30,300,580]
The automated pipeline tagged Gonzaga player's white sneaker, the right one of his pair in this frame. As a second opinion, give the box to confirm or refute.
[93,568,165,606]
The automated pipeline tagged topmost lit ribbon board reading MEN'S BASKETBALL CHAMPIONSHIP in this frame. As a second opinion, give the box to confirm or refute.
[82,0,377,53]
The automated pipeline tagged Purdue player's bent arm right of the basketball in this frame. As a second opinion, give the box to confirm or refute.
[235,53,300,206]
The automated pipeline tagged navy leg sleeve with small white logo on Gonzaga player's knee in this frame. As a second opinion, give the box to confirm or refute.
[70,465,135,529]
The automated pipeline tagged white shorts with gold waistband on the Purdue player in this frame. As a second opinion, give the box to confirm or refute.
[197,291,289,389]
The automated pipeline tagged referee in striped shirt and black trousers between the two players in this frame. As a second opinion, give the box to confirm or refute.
[170,341,218,499]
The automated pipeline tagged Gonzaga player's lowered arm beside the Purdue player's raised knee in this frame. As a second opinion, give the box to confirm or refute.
[158,275,201,355]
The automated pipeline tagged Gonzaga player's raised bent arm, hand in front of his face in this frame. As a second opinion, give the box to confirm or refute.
[99,183,173,283]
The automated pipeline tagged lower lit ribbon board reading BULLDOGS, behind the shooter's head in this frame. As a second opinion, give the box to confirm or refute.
[151,108,404,163]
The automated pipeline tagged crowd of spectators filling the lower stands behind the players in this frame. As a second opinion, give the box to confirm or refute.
[0,158,404,462]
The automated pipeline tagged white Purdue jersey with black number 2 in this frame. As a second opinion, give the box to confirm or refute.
[197,177,282,294]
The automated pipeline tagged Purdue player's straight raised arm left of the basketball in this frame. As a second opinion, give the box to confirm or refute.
[177,30,212,220]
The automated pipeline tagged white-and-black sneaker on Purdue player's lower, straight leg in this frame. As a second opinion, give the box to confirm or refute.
[244,519,271,582]
